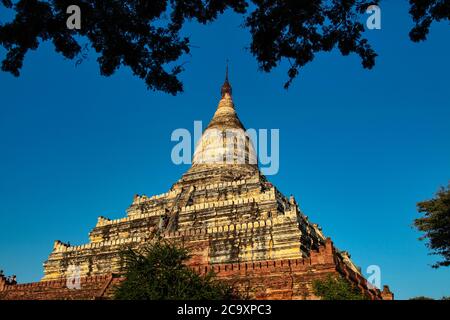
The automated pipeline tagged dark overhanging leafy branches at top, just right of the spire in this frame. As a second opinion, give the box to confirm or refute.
[245,0,378,88]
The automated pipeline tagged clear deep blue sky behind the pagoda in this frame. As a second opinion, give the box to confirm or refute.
[0,1,450,299]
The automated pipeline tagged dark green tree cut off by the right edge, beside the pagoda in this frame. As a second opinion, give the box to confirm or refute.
[414,184,450,268]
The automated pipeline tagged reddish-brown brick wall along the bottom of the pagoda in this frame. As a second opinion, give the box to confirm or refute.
[0,239,393,300]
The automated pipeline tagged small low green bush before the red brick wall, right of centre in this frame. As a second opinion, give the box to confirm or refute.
[313,275,368,300]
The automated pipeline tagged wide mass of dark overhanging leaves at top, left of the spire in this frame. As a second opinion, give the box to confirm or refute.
[0,0,246,94]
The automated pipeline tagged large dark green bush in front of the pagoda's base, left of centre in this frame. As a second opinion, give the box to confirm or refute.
[114,239,237,300]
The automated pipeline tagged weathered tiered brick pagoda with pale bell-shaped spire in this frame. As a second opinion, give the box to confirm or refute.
[0,74,393,299]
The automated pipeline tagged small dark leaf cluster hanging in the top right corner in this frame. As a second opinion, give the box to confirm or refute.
[409,0,450,42]
